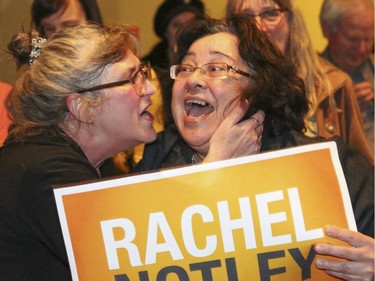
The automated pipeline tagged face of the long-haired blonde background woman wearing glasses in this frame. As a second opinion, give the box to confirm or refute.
[236,0,290,54]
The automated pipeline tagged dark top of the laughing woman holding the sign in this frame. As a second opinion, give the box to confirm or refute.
[133,126,374,237]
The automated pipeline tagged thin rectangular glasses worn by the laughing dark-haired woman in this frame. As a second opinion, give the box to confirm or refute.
[169,62,254,79]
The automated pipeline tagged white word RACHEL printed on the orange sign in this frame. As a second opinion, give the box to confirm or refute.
[101,187,324,270]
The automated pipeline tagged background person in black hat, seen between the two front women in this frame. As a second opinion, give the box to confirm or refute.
[114,0,204,173]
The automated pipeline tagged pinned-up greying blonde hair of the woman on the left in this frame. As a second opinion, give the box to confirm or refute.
[7,24,138,140]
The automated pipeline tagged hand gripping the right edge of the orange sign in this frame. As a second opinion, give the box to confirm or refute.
[315,226,374,281]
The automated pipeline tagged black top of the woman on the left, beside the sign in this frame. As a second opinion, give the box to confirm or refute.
[0,132,99,281]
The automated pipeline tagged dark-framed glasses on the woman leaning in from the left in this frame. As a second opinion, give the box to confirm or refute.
[77,62,151,96]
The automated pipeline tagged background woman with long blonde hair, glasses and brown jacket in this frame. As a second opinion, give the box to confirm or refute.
[227,0,374,163]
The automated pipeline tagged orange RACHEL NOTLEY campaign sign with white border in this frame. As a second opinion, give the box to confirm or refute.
[54,142,356,281]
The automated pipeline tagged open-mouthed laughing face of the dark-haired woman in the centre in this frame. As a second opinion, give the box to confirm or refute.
[172,33,250,155]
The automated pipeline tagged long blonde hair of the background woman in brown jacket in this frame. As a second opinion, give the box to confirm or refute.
[227,0,335,118]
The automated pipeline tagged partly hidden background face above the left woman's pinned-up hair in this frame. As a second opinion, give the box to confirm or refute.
[40,0,86,38]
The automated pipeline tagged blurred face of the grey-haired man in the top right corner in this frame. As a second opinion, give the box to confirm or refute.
[327,10,374,71]
